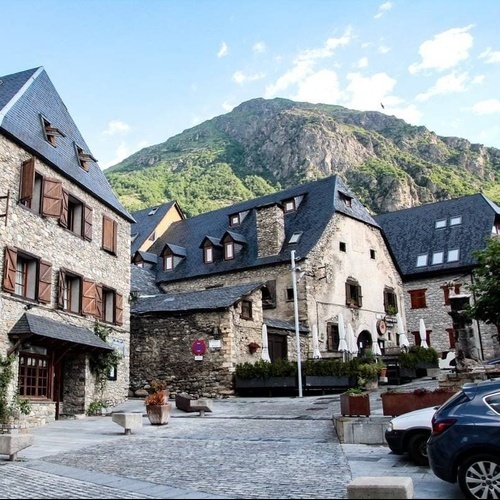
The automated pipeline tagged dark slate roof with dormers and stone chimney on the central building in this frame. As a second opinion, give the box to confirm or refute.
[149,176,378,283]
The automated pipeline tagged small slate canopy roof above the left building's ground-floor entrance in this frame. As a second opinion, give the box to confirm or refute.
[9,313,113,350]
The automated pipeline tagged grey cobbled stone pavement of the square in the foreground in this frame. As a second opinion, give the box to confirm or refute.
[0,379,464,499]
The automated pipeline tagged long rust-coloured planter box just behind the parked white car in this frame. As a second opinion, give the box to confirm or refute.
[380,389,455,417]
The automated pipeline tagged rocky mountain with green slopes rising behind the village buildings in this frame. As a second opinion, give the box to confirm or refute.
[104,98,500,216]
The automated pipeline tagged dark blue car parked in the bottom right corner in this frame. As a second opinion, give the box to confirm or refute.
[427,378,500,499]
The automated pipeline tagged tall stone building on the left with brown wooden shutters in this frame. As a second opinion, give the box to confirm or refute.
[0,67,134,425]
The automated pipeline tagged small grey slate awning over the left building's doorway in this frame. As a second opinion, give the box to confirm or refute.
[9,313,113,351]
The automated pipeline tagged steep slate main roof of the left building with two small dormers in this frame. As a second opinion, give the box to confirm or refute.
[0,67,134,222]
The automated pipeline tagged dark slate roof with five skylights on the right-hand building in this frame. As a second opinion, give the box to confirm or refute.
[375,194,500,279]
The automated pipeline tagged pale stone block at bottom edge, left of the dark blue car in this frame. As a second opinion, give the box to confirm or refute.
[347,476,414,500]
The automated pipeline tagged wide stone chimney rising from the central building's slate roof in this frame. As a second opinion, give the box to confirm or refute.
[256,203,285,257]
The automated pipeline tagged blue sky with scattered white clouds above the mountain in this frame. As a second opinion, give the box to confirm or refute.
[0,0,500,168]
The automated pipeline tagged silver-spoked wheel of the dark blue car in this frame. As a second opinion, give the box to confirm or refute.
[458,454,500,499]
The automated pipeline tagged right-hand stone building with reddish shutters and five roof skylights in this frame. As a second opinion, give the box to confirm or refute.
[375,194,500,360]
